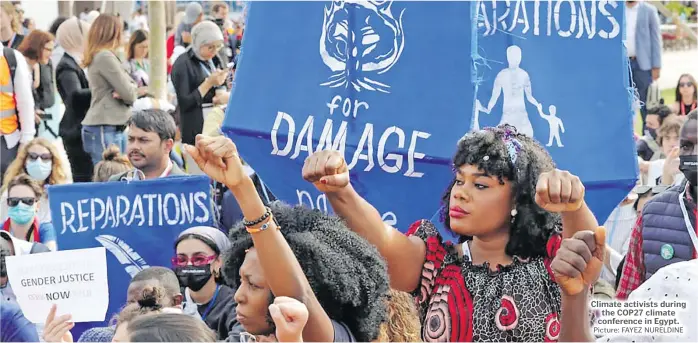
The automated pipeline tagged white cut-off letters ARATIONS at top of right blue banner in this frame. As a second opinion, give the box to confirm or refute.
[477,0,622,39]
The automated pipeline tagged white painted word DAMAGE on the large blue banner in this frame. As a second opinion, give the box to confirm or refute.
[271,111,431,177]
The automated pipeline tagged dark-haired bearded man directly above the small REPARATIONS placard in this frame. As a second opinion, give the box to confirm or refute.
[109,109,186,181]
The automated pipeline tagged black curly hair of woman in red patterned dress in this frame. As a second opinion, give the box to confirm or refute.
[441,124,560,258]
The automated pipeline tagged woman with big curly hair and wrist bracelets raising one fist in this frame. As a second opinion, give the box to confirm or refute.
[185,135,389,342]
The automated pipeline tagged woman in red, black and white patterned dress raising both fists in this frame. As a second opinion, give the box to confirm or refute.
[303,125,597,342]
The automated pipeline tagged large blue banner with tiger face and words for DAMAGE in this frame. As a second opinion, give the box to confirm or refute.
[223,1,473,230]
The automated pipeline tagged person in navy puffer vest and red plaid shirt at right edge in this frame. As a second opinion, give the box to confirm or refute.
[617,110,698,299]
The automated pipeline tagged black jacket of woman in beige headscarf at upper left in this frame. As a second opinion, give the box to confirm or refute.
[56,53,92,141]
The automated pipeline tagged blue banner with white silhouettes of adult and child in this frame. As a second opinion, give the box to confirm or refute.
[472,0,638,228]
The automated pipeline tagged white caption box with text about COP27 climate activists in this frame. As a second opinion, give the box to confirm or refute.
[591,300,687,335]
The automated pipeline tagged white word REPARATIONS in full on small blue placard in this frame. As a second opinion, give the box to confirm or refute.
[61,192,210,234]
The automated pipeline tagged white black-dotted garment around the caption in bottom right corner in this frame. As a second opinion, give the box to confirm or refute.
[596,260,698,342]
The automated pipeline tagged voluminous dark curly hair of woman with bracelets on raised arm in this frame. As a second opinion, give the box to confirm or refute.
[223,202,389,342]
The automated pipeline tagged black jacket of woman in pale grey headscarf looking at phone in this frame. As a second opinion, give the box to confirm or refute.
[171,49,223,144]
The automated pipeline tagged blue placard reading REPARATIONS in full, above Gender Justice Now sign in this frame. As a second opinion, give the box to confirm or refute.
[48,176,215,339]
